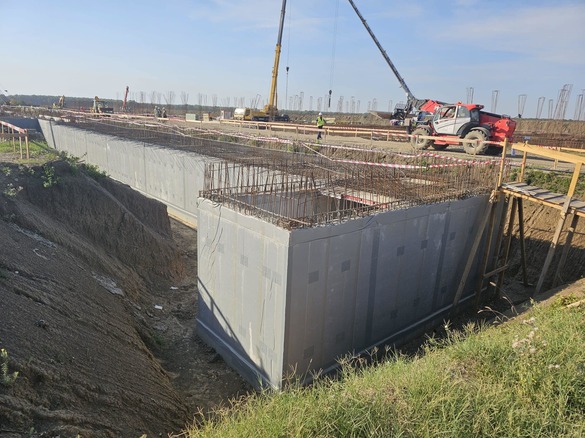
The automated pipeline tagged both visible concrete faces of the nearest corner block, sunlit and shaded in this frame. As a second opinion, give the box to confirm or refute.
[197,197,487,387]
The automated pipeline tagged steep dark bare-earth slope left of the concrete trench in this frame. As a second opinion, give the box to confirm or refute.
[0,161,188,436]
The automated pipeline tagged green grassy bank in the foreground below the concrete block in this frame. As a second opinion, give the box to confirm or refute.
[182,296,585,438]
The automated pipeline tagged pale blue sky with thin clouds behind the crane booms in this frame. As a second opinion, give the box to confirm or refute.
[0,0,585,118]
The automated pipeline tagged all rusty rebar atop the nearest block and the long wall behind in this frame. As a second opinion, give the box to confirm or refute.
[67,118,498,229]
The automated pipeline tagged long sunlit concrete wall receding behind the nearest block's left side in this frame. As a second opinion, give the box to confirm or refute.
[39,120,217,226]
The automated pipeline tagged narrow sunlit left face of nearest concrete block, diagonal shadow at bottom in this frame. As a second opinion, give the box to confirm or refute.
[197,199,290,387]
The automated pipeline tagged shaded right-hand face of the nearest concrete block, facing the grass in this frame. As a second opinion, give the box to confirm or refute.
[283,197,487,376]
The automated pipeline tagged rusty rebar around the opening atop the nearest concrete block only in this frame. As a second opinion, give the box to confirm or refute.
[200,158,498,229]
